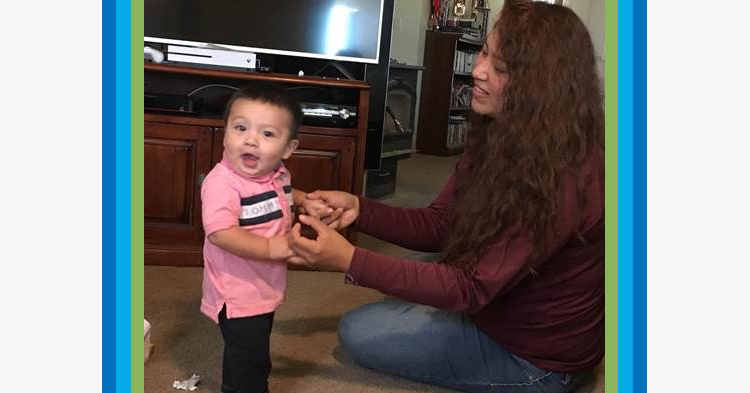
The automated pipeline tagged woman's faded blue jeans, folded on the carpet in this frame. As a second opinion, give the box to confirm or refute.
[339,299,589,393]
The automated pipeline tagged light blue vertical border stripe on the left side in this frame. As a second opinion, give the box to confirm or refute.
[114,1,131,393]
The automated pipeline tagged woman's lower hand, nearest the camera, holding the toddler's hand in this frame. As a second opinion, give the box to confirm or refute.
[287,215,354,272]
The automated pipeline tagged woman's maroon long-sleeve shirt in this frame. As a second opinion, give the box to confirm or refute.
[347,157,604,372]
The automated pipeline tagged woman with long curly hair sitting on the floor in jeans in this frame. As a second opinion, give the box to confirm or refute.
[290,0,604,392]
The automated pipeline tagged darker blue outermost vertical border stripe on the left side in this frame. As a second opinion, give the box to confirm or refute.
[102,1,115,392]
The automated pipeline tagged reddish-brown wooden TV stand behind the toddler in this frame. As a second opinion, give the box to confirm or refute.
[143,63,370,266]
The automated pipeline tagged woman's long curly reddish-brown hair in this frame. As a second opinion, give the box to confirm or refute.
[442,0,604,271]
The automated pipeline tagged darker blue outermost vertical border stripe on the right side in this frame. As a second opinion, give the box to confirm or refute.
[633,0,647,392]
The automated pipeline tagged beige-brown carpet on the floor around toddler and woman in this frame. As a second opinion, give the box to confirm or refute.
[144,155,604,393]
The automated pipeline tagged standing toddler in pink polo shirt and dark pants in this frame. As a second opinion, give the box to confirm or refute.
[201,84,325,393]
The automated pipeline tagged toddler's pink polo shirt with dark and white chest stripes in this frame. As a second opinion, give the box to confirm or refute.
[201,160,293,323]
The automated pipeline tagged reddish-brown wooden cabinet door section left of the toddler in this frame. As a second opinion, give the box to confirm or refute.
[143,122,214,265]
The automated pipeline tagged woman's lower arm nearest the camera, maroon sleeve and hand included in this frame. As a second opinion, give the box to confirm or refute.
[288,211,530,312]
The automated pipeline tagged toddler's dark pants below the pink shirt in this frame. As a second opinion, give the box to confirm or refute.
[219,306,274,393]
